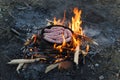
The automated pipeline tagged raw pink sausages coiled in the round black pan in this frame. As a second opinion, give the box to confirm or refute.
[43,26,72,44]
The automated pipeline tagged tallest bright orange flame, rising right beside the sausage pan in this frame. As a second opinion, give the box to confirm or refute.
[69,8,83,50]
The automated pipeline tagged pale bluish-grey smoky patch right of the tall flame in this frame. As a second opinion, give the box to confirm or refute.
[83,25,114,46]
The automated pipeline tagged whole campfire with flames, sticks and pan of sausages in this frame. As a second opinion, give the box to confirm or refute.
[8,8,98,73]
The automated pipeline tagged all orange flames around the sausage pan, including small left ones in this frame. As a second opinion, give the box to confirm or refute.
[24,8,91,64]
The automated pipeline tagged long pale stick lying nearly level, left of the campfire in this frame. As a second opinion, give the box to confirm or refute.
[8,58,46,64]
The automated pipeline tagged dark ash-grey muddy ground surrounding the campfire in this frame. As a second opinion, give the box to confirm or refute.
[0,0,120,80]
